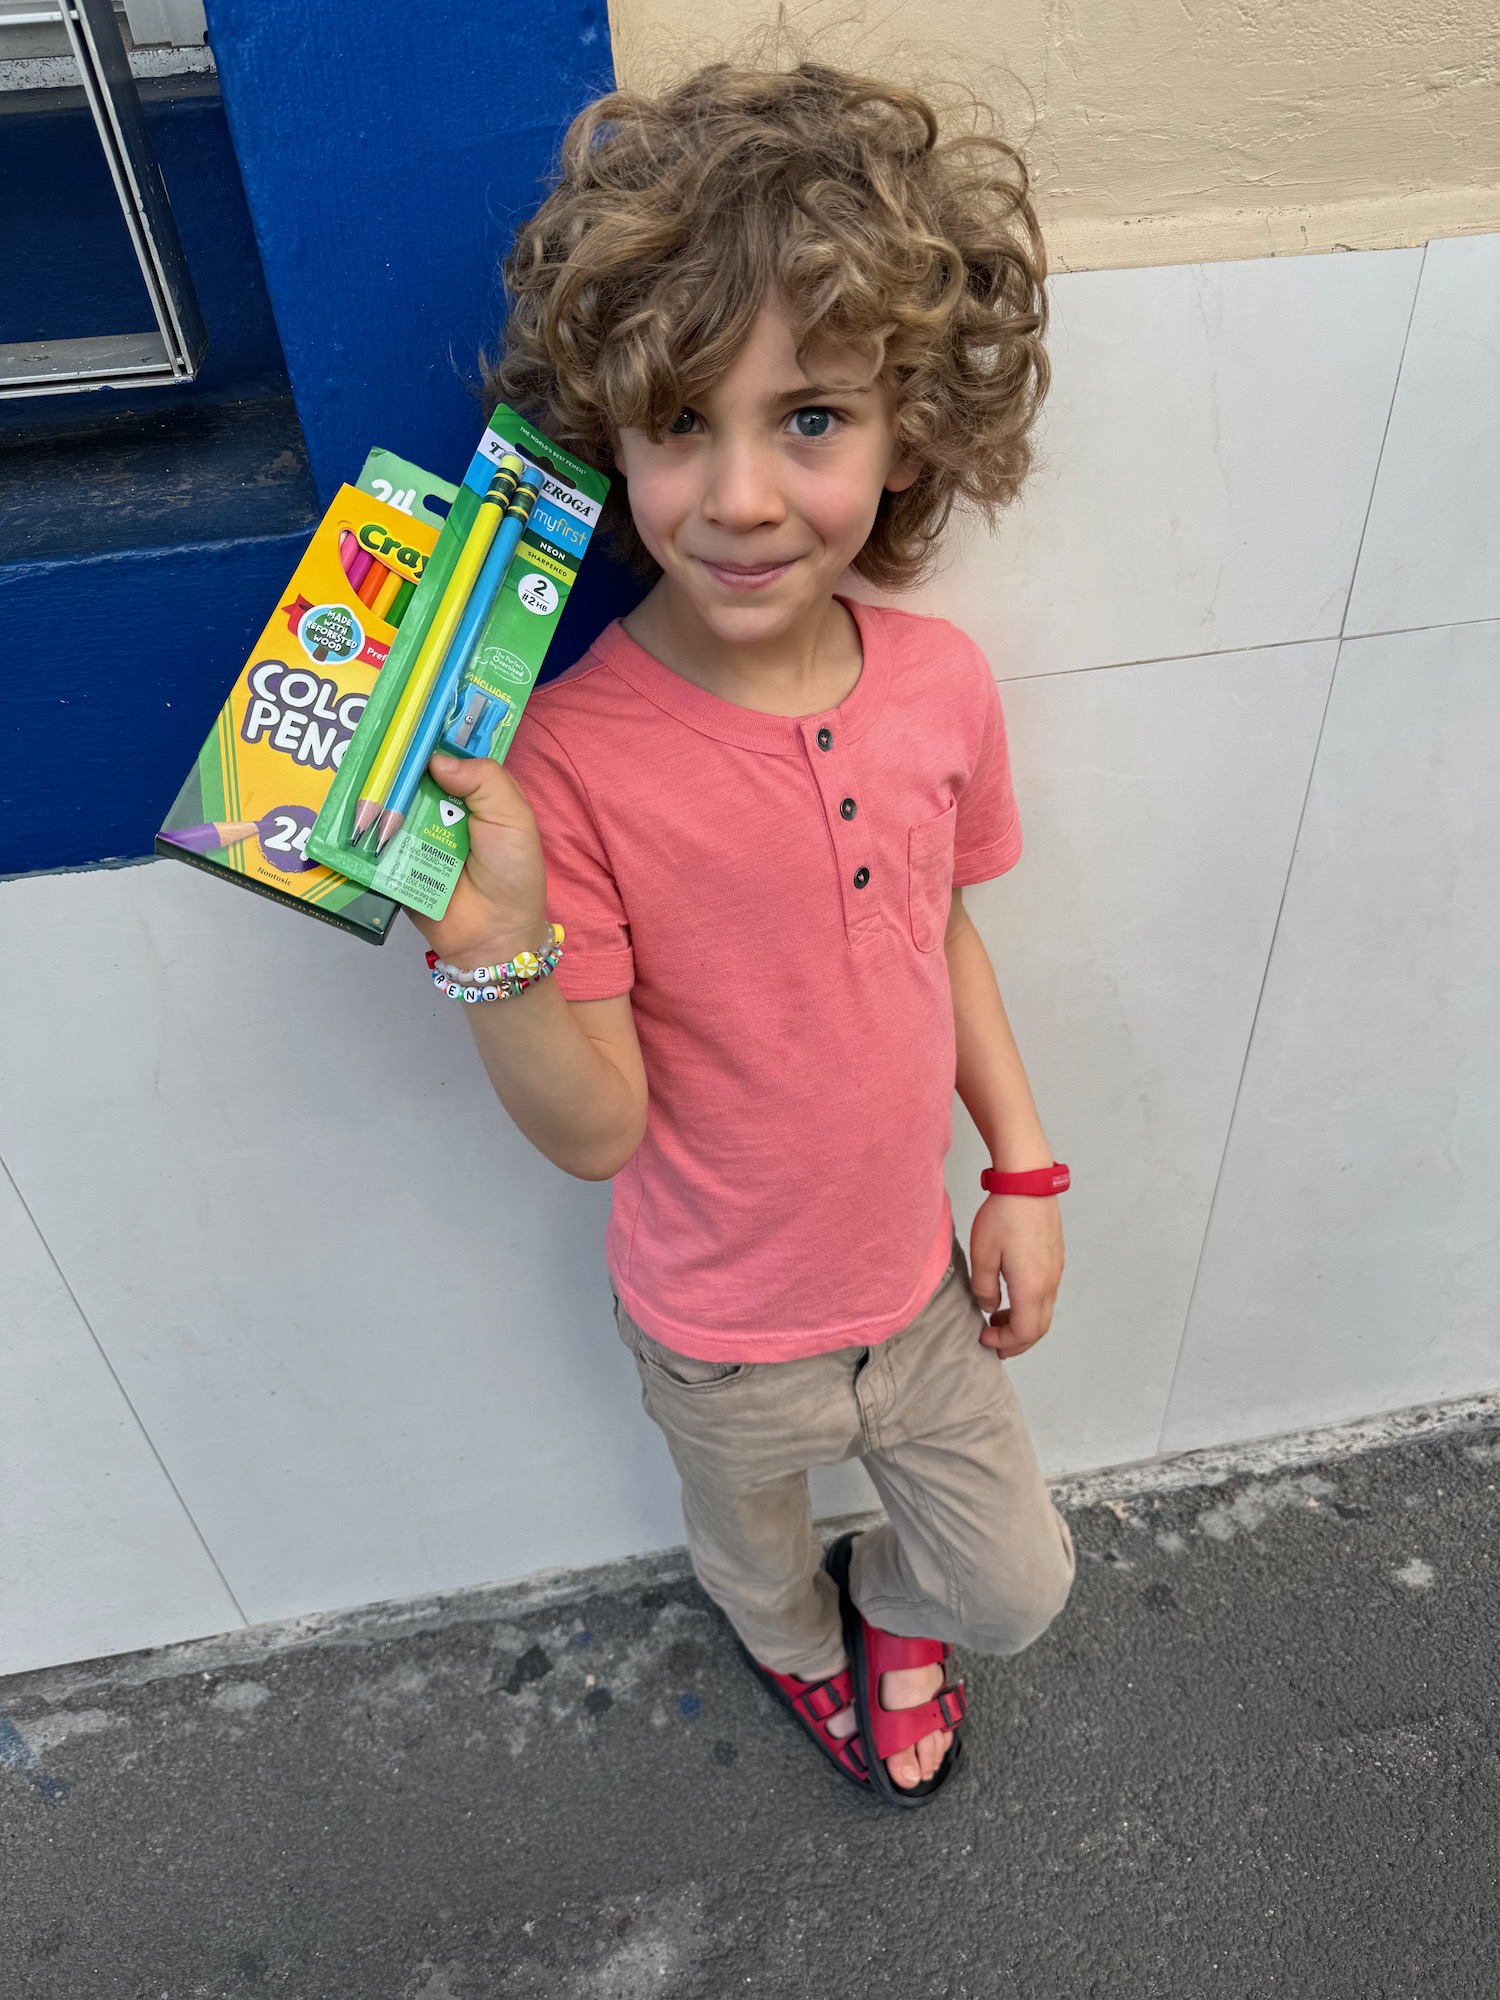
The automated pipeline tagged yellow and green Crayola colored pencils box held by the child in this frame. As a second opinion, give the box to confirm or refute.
[156,450,458,944]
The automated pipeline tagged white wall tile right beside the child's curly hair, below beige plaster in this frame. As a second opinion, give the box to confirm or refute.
[864,250,1422,678]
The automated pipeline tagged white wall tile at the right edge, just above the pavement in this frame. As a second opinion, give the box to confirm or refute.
[1164,622,1500,1450]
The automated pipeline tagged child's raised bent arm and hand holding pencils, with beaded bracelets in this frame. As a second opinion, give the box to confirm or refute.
[414,758,646,1180]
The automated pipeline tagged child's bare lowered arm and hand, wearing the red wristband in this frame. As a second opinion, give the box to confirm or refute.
[944,888,1062,1356]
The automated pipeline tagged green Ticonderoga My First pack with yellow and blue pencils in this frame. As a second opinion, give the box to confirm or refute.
[308,404,610,916]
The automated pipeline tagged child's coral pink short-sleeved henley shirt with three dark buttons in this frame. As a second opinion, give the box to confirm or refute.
[508,600,1020,1362]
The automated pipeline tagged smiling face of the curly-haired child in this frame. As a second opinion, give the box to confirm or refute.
[616,306,920,646]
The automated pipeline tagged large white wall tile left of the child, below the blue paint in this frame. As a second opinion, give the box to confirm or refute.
[0,862,682,1622]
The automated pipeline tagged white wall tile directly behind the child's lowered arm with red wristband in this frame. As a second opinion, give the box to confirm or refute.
[950,640,1338,1468]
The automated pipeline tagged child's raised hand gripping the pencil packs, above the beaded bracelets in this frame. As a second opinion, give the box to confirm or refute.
[412,756,546,970]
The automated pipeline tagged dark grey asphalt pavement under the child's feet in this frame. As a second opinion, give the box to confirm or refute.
[0,1418,1500,2000]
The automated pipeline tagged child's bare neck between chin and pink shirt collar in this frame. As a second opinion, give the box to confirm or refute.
[624,578,862,716]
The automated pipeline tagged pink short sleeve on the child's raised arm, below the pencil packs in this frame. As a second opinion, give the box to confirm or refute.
[506,716,636,1000]
